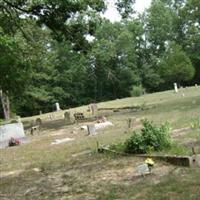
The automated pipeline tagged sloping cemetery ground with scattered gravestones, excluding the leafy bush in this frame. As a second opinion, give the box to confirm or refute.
[0,87,200,199]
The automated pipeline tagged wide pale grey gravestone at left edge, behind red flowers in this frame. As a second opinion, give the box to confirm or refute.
[0,123,26,148]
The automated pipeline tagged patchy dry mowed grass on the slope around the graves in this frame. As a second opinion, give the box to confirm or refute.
[0,87,200,200]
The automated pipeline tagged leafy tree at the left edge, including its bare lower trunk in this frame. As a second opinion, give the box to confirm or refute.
[0,27,30,119]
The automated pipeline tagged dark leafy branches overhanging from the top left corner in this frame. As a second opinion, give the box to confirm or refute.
[0,0,105,51]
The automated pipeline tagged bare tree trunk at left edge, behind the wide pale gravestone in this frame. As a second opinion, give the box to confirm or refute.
[0,90,10,120]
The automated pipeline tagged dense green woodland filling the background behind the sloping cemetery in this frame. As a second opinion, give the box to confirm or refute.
[0,0,200,117]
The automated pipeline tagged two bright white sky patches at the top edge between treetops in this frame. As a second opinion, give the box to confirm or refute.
[104,0,151,22]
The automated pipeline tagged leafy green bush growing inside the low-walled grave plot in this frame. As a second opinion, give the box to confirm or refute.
[125,120,172,153]
